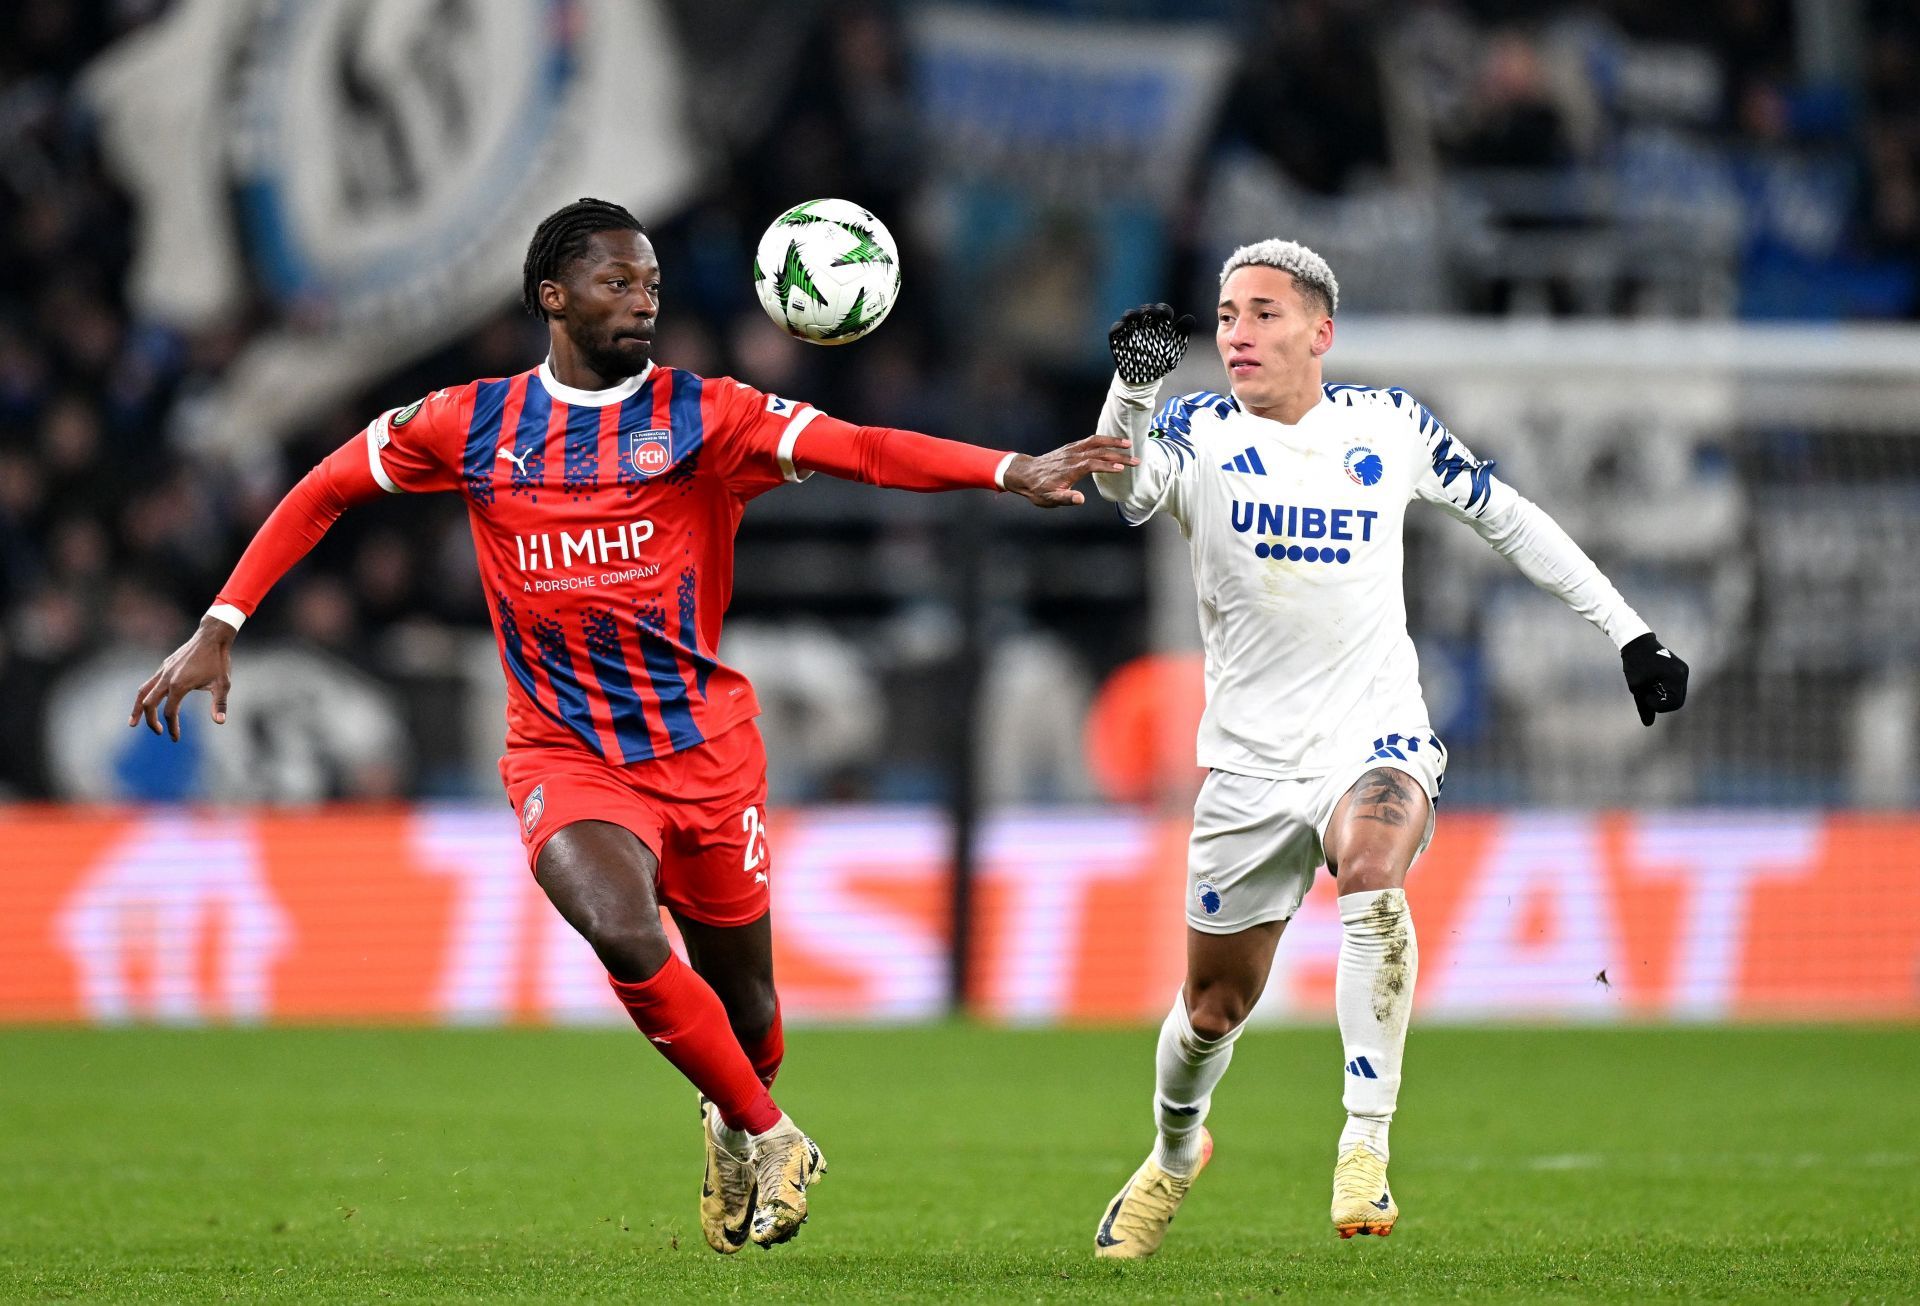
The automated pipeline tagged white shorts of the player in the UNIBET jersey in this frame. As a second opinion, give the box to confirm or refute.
[1187,728,1446,933]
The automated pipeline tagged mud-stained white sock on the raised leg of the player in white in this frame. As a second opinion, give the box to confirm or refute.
[1344,889,1421,1160]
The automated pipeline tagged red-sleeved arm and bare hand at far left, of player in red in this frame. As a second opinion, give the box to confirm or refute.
[127,432,382,739]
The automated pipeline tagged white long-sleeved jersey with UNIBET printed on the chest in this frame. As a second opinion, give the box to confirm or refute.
[1094,376,1647,780]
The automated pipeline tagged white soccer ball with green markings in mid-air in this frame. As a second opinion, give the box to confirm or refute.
[753,200,900,344]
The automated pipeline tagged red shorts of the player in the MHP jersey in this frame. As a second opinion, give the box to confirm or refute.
[499,720,772,926]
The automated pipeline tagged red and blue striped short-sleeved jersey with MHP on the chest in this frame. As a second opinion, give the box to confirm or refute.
[367,365,879,764]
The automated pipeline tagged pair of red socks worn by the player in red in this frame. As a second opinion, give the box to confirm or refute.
[607,956,783,1133]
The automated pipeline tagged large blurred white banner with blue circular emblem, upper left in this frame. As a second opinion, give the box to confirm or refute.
[86,0,695,449]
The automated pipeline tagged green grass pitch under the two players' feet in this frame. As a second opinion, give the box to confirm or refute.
[0,1028,1920,1302]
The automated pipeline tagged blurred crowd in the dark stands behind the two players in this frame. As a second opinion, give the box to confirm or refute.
[0,0,1920,801]
